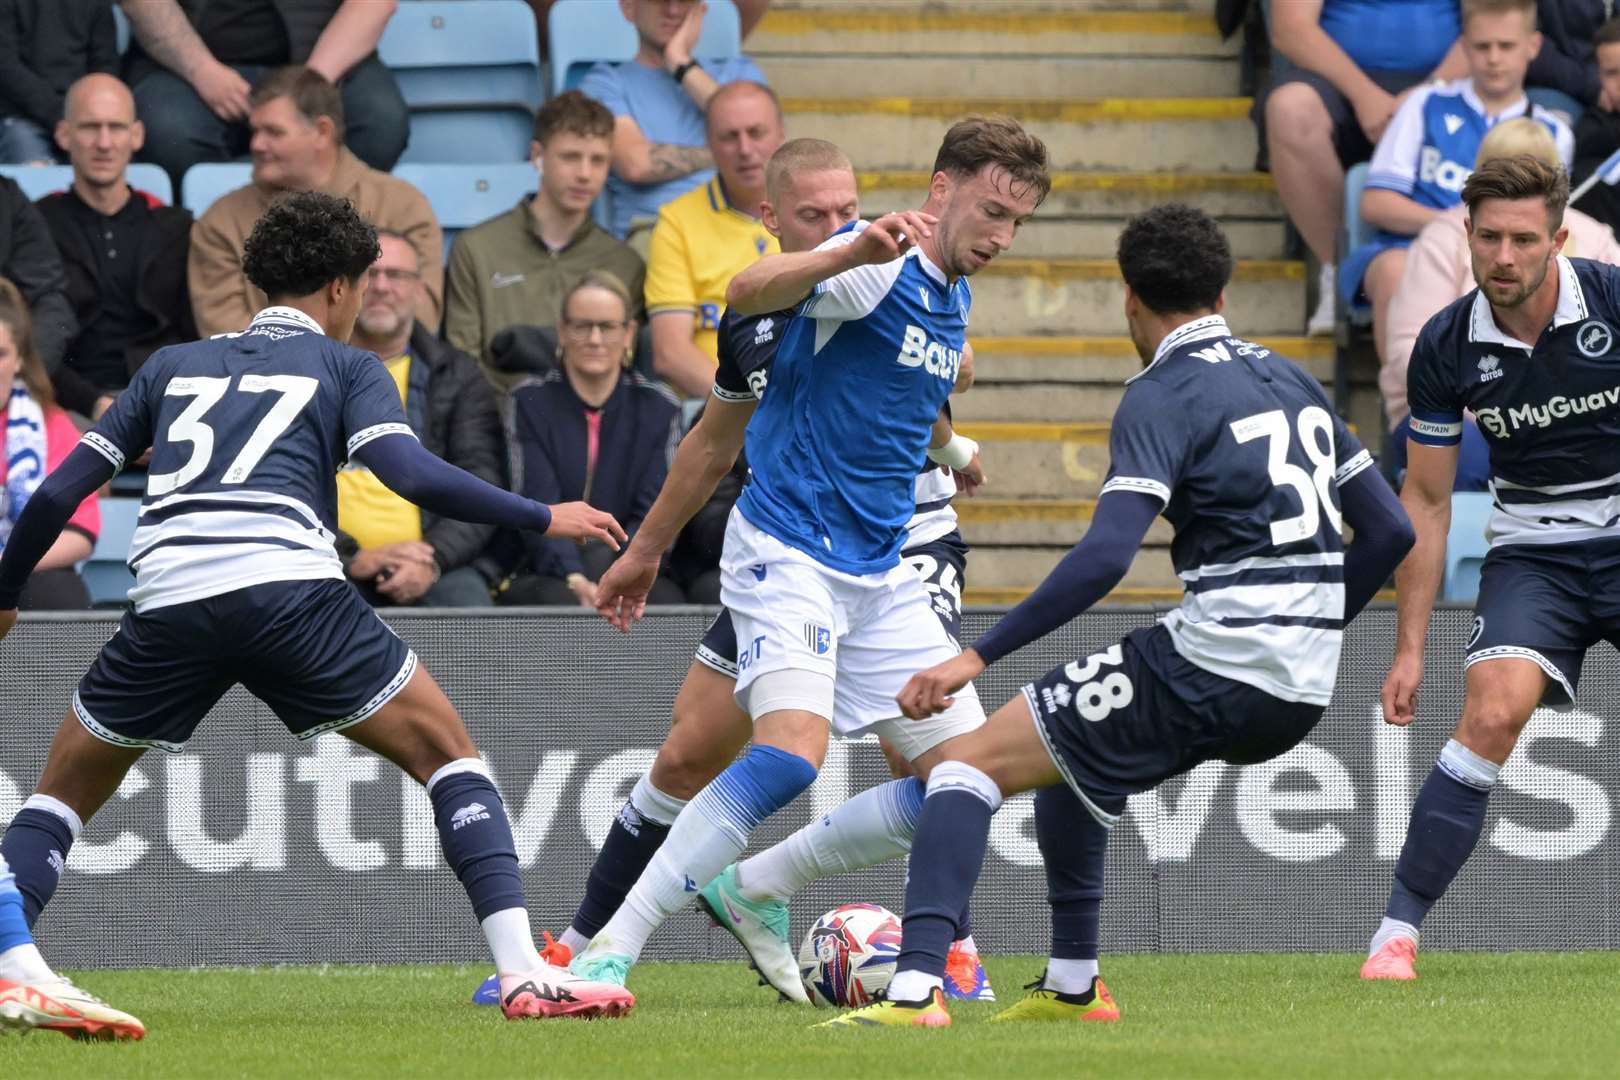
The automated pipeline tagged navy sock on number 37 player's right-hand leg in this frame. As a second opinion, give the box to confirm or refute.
[428,758,523,923]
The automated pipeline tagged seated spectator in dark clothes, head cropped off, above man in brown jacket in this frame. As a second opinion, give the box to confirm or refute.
[118,0,410,191]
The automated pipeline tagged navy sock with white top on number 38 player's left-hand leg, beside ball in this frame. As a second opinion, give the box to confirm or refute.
[896,761,1001,1001]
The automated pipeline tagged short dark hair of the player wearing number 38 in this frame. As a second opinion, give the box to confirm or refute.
[1118,202,1231,314]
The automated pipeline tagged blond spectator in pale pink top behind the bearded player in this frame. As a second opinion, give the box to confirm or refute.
[1379,117,1620,491]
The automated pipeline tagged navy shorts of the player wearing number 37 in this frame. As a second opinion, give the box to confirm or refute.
[73,578,416,753]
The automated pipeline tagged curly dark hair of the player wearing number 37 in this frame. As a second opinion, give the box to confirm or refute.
[241,191,382,301]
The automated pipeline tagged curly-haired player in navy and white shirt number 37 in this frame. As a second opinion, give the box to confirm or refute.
[0,194,633,1018]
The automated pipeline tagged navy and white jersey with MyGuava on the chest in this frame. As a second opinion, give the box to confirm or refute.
[1406,256,1620,544]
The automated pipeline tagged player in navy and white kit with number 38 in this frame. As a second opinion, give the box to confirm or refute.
[834,206,1411,1027]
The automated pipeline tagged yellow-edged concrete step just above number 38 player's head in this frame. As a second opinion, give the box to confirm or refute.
[857,168,1283,221]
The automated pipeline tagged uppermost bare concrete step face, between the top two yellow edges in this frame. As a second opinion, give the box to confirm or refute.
[755,52,1239,99]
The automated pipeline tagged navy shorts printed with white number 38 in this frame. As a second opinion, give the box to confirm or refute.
[1024,625,1324,827]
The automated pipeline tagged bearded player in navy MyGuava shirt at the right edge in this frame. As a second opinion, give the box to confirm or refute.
[1361,155,1620,980]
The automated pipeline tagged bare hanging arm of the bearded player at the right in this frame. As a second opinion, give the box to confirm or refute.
[1382,439,1458,725]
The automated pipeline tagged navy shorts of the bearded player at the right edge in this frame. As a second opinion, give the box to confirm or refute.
[1463,539,1620,706]
